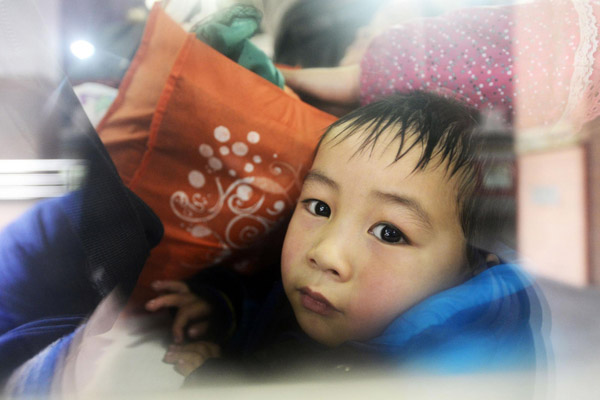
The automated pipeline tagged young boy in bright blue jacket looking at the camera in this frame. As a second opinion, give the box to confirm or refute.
[146,92,532,379]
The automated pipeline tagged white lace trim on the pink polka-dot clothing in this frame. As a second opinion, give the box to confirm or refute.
[560,0,598,121]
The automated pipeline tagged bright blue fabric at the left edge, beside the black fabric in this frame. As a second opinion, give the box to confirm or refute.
[0,192,102,333]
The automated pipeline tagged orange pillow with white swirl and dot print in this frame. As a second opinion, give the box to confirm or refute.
[99,8,336,298]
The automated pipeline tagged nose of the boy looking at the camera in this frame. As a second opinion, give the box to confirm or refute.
[307,225,352,282]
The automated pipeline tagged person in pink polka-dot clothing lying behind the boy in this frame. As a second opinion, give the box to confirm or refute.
[282,0,600,132]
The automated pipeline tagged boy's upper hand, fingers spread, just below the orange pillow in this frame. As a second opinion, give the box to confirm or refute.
[146,281,212,344]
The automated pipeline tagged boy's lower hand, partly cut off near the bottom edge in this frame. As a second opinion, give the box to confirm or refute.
[163,342,221,376]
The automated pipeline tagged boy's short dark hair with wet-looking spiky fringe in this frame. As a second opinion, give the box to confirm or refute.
[315,91,481,267]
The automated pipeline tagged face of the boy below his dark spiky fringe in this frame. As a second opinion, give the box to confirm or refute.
[281,126,467,346]
